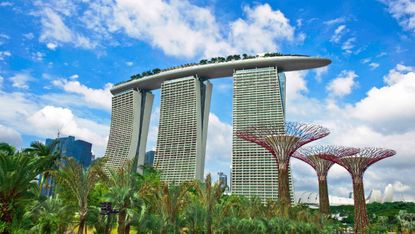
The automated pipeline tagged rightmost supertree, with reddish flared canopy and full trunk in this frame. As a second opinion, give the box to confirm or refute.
[320,147,396,233]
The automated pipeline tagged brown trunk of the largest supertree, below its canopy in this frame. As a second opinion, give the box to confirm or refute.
[278,163,291,216]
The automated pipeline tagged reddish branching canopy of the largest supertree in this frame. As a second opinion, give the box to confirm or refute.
[236,122,330,157]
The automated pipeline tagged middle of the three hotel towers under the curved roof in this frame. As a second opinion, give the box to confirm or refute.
[154,77,212,183]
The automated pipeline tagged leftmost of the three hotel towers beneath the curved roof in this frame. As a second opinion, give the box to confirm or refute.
[105,89,154,172]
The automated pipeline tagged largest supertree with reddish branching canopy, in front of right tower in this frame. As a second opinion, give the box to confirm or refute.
[236,122,330,208]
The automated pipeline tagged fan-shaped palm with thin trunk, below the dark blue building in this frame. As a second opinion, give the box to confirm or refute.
[52,158,105,234]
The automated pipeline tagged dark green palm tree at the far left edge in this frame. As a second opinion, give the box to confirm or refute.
[0,145,47,233]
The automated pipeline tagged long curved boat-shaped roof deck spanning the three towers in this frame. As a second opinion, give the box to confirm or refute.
[111,56,331,94]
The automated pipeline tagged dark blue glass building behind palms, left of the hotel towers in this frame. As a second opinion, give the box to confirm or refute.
[45,136,93,167]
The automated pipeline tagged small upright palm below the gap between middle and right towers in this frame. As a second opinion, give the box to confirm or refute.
[194,174,224,234]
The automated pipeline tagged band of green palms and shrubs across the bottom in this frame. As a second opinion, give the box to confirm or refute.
[4,142,415,234]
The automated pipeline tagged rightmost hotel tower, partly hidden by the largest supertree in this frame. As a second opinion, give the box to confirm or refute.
[231,67,292,201]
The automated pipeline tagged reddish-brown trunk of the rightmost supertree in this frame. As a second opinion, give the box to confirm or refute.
[353,175,369,233]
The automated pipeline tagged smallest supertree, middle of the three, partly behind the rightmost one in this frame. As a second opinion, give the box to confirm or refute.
[292,145,359,214]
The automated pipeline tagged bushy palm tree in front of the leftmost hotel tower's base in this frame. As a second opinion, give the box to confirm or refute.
[107,161,142,234]
